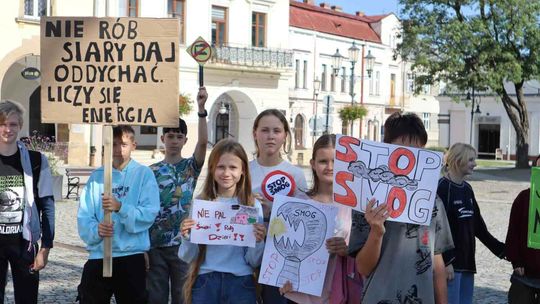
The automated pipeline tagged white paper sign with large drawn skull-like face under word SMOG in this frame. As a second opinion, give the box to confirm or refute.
[259,195,337,296]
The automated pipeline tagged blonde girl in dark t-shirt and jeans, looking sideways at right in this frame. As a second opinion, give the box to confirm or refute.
[437,143,504,304]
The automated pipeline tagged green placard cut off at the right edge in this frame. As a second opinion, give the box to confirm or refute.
[527,167,540,249]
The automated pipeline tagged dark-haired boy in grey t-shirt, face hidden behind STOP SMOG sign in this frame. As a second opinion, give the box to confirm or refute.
[349,112,453,303]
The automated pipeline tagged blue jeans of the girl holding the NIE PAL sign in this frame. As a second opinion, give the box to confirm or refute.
[191,271,257,304]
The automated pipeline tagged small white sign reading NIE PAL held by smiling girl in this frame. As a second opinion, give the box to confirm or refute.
[190,199,259,247]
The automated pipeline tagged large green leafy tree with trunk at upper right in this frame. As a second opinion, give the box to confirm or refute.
[398,0,540,168]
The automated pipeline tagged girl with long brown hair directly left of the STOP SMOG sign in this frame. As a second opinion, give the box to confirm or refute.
[279,134,352,304]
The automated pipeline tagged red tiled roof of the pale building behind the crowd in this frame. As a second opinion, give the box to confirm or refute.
[289,0,385,43]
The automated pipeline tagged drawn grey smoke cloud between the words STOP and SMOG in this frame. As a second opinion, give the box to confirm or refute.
[349,160,418,191]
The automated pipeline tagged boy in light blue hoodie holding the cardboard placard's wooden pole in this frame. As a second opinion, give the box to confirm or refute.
[77,126,159,304]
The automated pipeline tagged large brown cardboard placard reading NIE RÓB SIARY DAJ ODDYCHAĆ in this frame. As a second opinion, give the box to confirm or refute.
[41,17,179,127]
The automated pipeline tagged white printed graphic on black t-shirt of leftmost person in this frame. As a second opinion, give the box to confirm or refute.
[0,175,24,235]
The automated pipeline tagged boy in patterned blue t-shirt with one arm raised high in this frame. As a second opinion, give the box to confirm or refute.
[147,87,208,304]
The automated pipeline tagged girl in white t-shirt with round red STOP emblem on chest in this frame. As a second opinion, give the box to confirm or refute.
[249,109,307,304]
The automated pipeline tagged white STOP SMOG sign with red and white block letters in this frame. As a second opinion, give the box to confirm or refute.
[334,135,443,225]
